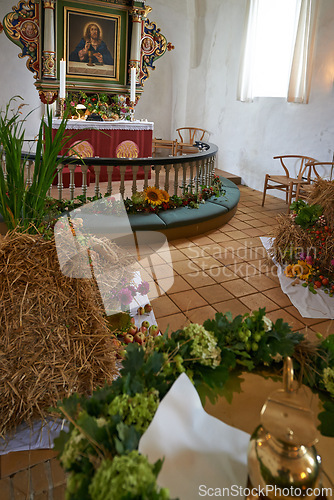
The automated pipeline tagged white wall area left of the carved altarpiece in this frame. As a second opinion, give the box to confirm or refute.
[0,0,44,139]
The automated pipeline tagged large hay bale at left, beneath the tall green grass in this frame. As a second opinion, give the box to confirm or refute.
[0,232,124,436]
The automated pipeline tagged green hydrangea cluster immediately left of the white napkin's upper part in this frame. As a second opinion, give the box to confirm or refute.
[108,390,160,432]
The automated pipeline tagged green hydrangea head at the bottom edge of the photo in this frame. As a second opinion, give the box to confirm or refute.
[89,450,169,500]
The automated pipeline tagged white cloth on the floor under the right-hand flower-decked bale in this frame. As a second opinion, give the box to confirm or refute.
[260,238,334,319]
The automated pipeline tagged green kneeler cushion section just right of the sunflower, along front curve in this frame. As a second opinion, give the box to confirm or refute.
[159,201,228,228]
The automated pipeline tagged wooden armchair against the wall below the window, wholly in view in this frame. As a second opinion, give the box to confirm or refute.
[262,155,316,211]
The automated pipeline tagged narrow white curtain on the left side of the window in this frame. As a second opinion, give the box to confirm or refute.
[237,0,259,102]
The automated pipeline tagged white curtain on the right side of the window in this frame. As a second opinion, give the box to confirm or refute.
[288,0,319,104]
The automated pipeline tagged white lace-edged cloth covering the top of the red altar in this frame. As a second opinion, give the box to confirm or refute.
[52,118,154,130]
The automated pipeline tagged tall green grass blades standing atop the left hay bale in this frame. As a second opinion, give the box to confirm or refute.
[0,96,69,231]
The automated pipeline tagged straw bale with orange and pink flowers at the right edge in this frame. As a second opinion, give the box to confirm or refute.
[284,201,334,297]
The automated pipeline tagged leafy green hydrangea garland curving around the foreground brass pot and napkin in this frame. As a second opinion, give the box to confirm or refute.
[55,309,334,500]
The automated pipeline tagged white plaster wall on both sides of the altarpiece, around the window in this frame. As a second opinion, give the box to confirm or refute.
[0,0,334,190]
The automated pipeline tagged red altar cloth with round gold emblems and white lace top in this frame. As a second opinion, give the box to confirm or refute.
[52,119,153,185]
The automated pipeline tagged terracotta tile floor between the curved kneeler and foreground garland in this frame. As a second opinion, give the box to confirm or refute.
[151,186,334,339]
